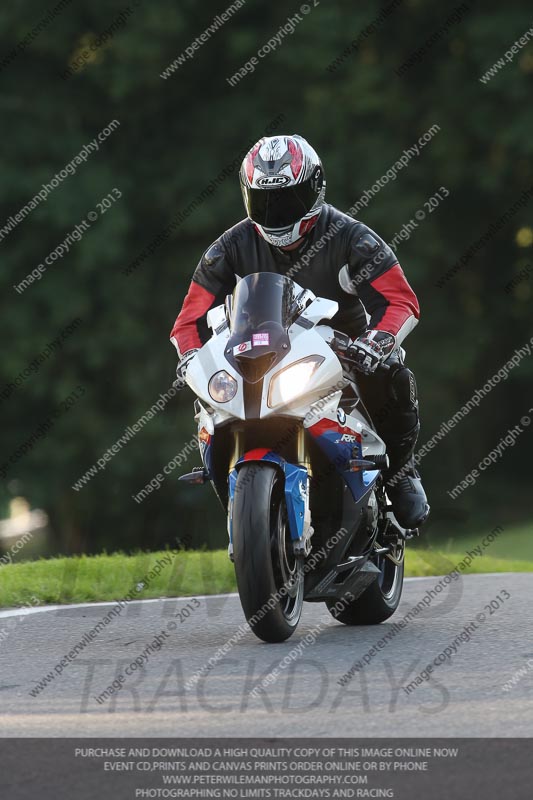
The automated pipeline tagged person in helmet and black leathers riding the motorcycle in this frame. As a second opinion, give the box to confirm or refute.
[171,134,429,528]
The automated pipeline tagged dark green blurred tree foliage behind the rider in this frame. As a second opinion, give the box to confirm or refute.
[0,0,533,552]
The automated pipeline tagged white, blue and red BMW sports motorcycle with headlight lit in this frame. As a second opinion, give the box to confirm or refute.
[180,272,416,642]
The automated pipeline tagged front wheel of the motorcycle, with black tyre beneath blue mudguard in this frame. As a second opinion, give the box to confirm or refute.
[233,462,304,642]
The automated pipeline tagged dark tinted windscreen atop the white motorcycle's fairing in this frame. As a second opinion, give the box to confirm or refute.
[230,272,301,342]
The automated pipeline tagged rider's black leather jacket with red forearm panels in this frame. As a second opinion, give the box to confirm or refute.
[171,204,420,355]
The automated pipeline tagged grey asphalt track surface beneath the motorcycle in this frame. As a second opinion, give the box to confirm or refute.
[0,574,533,737]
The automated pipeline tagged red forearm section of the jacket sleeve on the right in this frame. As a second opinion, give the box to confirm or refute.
[359,264,420,335]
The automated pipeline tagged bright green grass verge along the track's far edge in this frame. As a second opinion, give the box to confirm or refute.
[0,529,533,608]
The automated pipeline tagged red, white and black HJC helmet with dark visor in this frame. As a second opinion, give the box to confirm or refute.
[239,134,326,247]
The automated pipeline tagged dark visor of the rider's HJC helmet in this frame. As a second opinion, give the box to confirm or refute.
[244,179,317,229]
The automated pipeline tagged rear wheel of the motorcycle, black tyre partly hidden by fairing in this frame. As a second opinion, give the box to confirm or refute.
[326,541,405,625]
